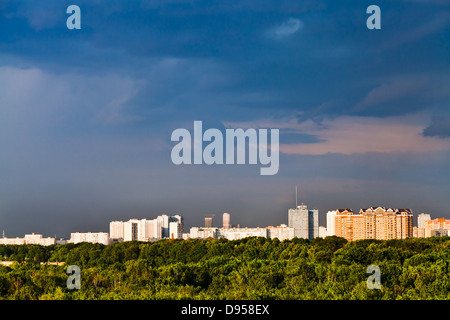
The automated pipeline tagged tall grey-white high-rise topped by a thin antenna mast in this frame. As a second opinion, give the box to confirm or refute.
[288,204,319,239]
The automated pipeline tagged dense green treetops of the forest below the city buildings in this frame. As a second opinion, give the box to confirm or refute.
[0,237,450,299]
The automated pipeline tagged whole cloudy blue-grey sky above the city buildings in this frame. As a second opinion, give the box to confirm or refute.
[0,0,450,238]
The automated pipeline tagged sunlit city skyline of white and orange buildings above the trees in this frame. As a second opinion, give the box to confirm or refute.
[0,204,450,246]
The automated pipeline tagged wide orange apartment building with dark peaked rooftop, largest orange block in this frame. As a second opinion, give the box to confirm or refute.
[334,207,413,241]
